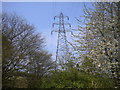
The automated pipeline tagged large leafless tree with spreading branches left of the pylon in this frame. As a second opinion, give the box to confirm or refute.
[2,13,52,87]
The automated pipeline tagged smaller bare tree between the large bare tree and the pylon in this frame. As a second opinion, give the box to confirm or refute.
[27,51,54,88]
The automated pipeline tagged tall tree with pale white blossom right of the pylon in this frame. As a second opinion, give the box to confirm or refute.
[70,2,120,88]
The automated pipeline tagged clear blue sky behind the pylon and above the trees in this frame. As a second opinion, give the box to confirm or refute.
[2,2,91,57]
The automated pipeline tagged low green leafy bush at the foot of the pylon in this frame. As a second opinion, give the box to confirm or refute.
[42,68,113,88]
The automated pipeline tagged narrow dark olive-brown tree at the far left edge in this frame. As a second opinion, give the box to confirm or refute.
[2,35,13,87]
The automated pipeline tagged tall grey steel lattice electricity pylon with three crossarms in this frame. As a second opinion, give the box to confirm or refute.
[51,12,71,68]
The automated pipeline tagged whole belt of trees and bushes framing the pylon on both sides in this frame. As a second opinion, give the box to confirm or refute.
[2,2,120,88]
